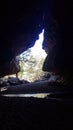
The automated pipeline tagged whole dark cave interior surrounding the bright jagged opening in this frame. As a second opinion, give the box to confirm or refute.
[0,0,73,130]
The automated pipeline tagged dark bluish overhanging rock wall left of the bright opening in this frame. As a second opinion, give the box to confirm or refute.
[0,0,46,76]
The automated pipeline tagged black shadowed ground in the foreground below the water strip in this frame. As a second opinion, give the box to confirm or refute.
[0,97,73,130]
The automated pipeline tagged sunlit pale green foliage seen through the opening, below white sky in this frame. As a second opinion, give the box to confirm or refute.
[17,49,44,82]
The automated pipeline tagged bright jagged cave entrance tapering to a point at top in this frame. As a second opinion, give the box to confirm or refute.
[17,29,47,82]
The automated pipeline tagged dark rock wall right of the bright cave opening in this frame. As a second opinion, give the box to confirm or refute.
[43,1,73,85]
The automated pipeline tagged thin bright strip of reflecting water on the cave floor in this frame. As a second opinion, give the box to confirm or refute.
[2,93,50,98]
